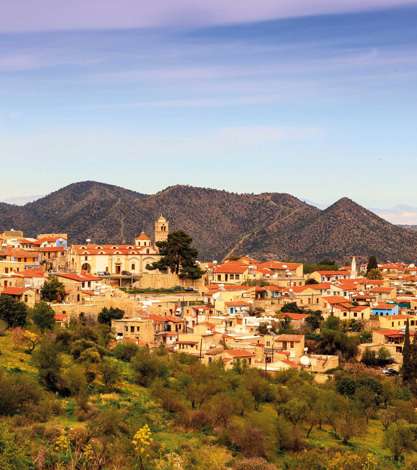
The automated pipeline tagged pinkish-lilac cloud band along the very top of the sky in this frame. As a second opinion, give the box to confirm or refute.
[0,0,416,32]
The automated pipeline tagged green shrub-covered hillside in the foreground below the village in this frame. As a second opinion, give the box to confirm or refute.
[0,322,416,470]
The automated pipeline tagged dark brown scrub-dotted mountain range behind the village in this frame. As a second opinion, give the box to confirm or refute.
[0,181,417,261]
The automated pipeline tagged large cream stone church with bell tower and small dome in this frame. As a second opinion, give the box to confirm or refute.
[68,215,169,276]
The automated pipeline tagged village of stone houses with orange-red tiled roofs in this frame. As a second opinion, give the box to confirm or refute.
[0,216,417,381]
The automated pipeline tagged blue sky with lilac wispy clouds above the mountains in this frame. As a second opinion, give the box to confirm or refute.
[0,0,417,223]
